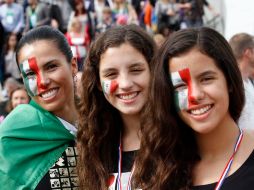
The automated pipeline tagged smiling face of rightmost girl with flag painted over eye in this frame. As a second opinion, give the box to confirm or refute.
[169,49,230,133]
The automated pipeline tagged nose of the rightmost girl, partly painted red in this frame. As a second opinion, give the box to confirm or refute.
[188,83,205,105]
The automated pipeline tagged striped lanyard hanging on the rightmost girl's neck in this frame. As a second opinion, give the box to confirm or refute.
[214,128,243,190]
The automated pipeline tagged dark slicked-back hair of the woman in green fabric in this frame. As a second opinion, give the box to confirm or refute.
[16,26,73,66]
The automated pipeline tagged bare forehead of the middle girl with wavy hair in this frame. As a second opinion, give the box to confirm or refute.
[100,43,148,70]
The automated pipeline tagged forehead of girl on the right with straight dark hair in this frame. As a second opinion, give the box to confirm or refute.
[168,49,219,74]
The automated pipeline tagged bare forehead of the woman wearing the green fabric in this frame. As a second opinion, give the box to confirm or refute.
[18,40,65,65]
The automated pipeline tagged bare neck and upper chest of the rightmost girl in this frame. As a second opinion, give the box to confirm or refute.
[193,117,243,185]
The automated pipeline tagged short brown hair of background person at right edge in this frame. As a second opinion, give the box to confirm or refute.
[229,33,254,60]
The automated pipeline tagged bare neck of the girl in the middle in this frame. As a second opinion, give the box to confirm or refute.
[119,115,140,151]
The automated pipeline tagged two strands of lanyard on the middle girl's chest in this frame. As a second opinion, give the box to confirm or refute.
[117,135,135,190]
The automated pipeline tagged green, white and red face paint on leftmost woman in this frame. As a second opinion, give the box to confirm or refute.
[20,57,45,97]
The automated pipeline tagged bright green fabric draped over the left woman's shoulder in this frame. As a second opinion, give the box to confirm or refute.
[0,101,75,190]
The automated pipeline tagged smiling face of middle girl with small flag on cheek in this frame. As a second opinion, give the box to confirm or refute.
[99,43,150,115]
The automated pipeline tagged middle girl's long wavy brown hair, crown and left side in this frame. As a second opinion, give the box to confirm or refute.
[77,25,155,190]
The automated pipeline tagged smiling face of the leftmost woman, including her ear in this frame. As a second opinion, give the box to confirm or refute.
[18,40,76,115]
